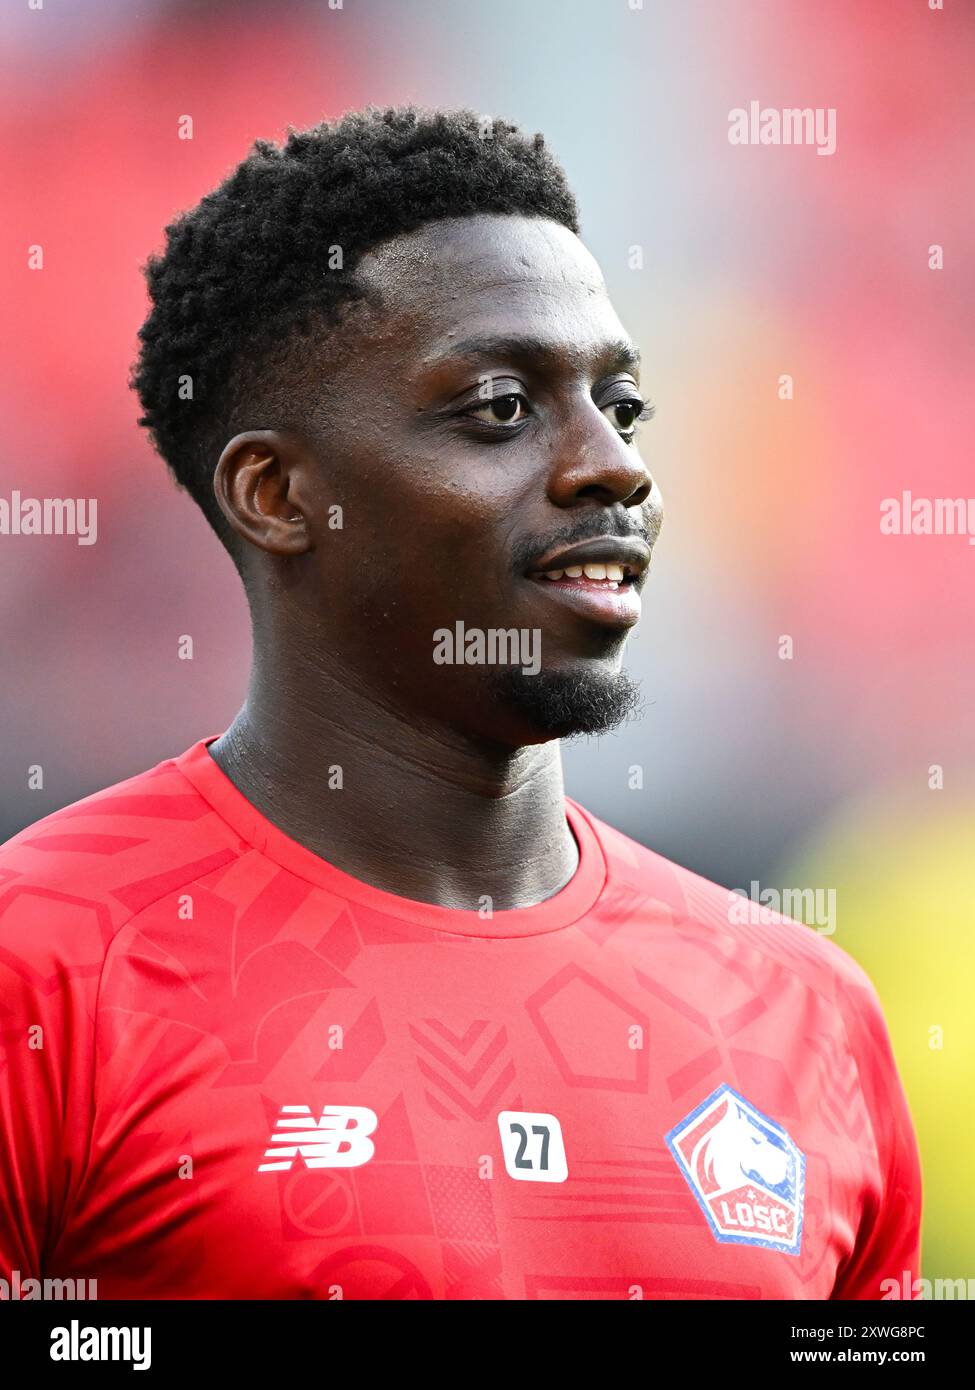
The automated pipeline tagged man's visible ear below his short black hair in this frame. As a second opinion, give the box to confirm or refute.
[213,430,312,556]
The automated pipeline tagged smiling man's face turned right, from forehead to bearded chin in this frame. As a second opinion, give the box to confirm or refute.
[289,215,662,745]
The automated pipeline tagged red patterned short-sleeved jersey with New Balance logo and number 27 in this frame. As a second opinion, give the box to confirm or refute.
[0,735,921,1300]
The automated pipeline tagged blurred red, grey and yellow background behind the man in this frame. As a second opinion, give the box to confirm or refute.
[0,0,975,1277]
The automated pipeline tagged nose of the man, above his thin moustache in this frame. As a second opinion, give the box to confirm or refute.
[548,402,654,507]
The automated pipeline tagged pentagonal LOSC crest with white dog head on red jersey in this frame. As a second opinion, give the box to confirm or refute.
[665,1084,805,1255]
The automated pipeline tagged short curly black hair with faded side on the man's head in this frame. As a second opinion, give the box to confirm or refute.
[131,106,579,560]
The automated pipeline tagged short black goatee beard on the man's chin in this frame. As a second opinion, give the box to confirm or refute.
[488,666,643,741]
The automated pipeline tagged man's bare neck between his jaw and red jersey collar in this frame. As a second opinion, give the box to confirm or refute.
[210,661,579,912]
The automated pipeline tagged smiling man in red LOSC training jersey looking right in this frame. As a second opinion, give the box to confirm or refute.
[0,110,921,1298]
